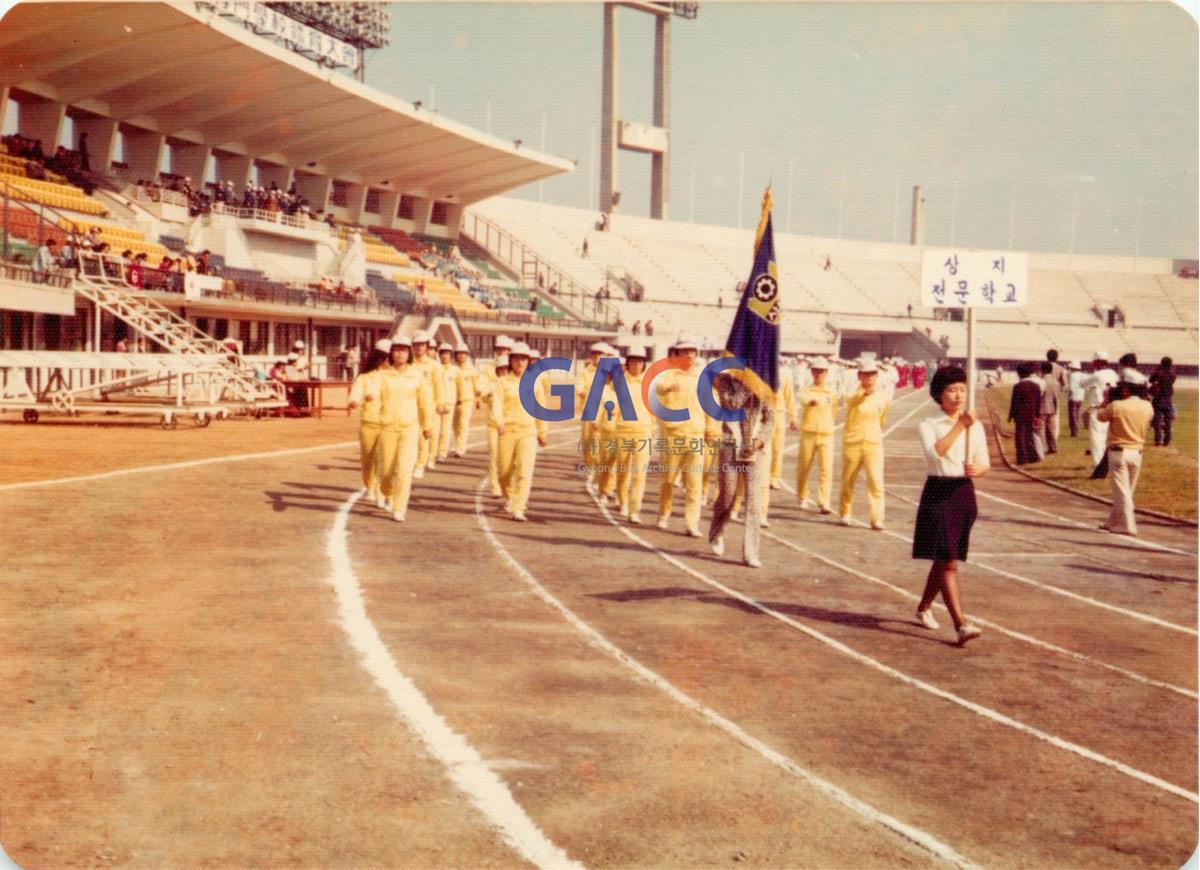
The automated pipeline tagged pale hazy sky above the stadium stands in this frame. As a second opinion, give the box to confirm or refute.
[366,2,1200,258]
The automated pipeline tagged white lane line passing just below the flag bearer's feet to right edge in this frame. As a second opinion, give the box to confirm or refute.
[596,492,1200,803]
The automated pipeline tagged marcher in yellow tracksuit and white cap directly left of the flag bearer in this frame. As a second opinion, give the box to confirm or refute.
[654,337,706,538]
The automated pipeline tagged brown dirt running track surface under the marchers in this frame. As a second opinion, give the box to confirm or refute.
[0,394,1198,868]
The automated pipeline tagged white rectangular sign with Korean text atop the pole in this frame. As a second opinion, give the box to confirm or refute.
[920,248,1030,308]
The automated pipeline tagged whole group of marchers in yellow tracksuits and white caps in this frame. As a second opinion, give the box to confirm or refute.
[350,331,890,538]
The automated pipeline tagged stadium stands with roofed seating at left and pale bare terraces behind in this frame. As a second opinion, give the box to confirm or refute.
[0,2,1198,421]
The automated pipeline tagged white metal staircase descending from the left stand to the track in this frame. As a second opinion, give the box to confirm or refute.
[74,253,287,409]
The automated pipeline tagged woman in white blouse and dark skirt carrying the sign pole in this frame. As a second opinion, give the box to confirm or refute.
[912,366,991,646]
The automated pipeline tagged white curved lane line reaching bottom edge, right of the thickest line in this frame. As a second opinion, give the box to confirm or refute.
[475,478,977,868]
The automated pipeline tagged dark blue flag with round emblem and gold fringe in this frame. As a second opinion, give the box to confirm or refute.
[725,187,784,406]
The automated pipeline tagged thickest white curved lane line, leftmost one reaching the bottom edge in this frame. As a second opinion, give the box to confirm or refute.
[326,491,582,868]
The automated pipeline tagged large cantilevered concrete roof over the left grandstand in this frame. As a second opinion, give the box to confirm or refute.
[0,2,575,203]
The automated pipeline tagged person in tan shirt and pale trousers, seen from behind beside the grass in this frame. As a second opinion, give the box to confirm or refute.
[1096,368,1154,535]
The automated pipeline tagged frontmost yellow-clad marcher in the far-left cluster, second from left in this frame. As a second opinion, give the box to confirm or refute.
[368,336,433,522]
